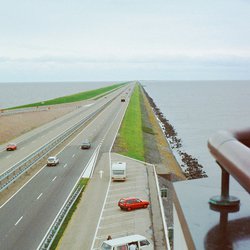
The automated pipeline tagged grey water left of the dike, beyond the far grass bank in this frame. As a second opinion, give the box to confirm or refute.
[0,82,114,109]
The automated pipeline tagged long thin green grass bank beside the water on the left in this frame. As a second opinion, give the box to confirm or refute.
[8,82,127,109]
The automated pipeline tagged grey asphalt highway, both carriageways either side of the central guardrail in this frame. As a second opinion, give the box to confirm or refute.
[0,83,133,250]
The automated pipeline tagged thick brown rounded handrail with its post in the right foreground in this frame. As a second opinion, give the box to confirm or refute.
[208,128,250,207]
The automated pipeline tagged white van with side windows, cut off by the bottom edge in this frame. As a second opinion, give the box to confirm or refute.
[100,234,154,250]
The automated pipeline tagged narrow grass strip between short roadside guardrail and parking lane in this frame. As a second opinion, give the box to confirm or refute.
[50,178,89,250]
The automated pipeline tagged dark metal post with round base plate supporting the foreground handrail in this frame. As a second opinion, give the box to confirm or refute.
[209,162,240,207]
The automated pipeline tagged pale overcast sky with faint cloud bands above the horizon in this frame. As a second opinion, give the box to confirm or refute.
[0,0,250,82]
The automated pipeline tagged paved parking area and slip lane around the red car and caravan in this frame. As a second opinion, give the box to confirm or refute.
[58,153,167,250]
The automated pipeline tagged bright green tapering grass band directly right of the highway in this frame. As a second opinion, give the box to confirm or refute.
[116,84,145,161]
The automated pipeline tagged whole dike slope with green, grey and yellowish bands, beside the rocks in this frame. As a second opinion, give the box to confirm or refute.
[113,83,185,179]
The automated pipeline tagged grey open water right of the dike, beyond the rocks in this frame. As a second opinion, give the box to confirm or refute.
[141,81,250,176]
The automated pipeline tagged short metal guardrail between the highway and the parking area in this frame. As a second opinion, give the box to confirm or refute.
[39,185,84,250]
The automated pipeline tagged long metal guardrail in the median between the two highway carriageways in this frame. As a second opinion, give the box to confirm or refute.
[0,96,114,192]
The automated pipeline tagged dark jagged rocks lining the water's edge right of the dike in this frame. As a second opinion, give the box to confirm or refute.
[142,87,207,180]
